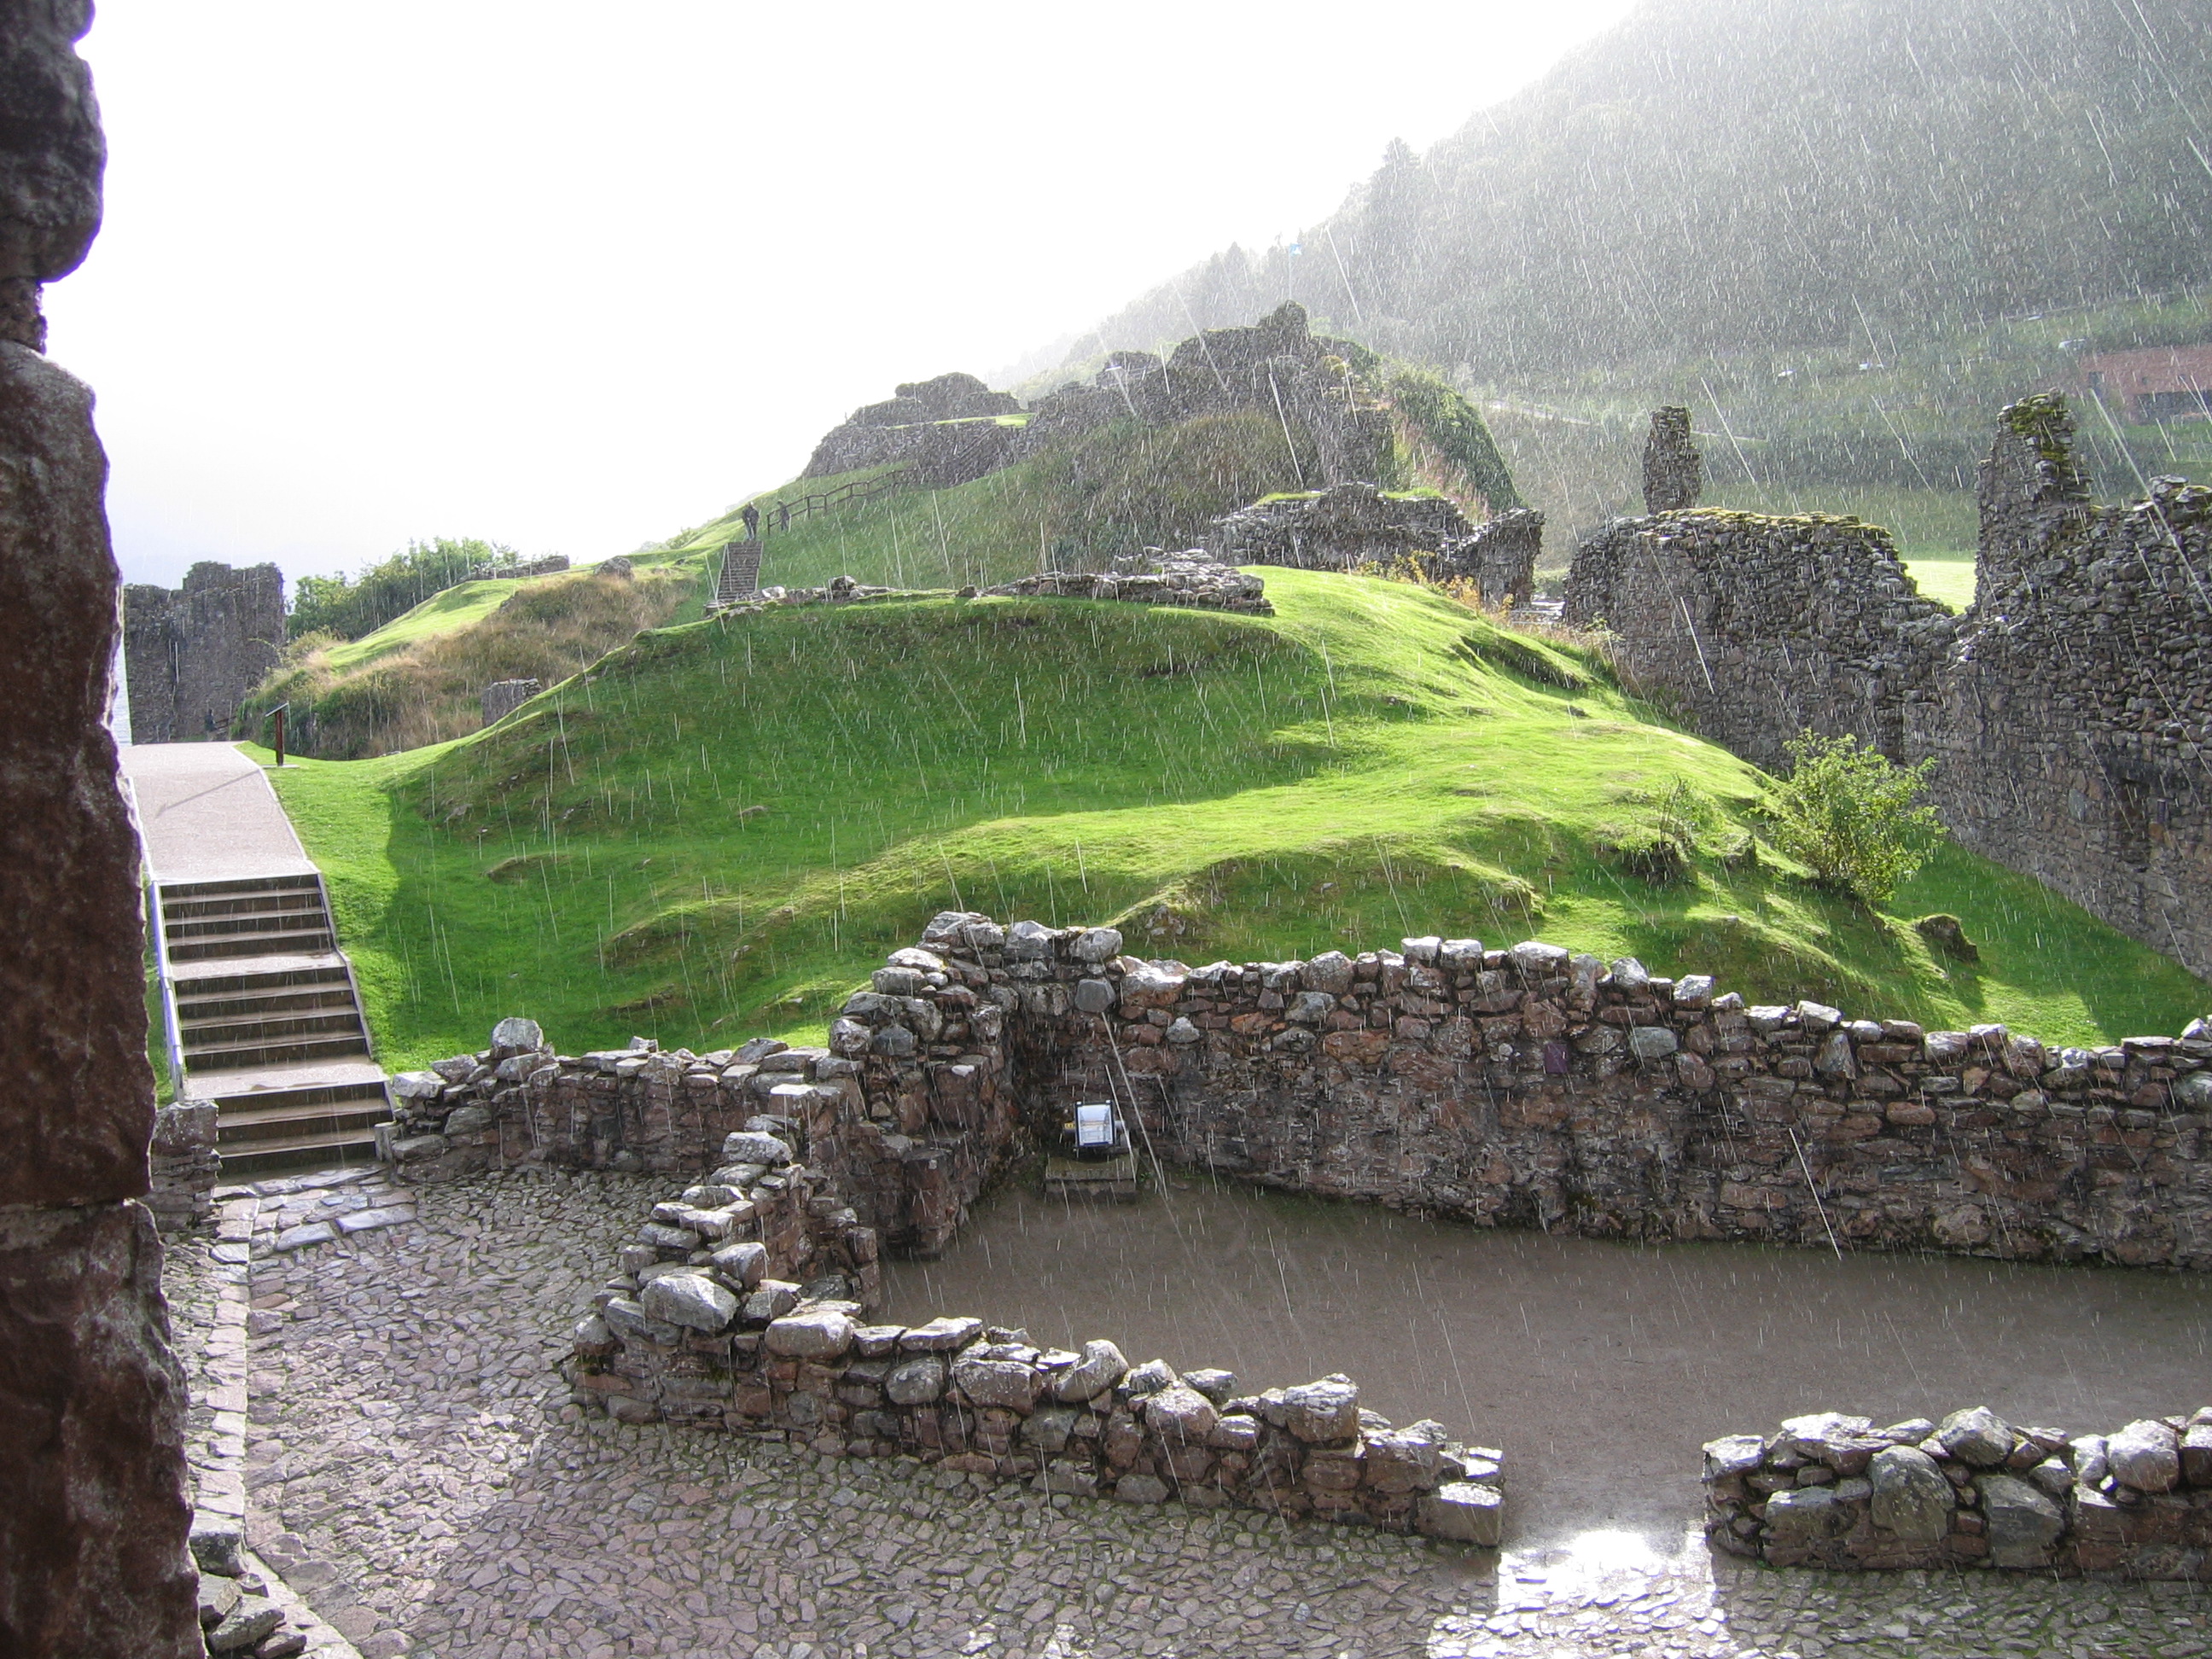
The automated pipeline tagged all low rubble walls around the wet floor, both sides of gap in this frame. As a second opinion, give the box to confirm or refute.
[392,911,2212,1580]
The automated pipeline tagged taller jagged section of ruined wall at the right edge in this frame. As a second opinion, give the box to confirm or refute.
[1905,399,2212,978]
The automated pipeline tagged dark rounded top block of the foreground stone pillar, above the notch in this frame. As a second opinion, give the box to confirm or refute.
[0,0,108,352]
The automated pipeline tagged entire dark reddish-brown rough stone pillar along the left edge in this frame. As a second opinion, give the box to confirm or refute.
[0,0,203,1659]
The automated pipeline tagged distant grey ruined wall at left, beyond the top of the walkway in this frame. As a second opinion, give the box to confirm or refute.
[124,562,285,743]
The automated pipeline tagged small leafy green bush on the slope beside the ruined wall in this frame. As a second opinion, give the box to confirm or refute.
[1767,730,1942,905]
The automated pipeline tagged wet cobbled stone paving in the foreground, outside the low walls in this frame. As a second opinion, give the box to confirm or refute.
[175,1174,2212,1659]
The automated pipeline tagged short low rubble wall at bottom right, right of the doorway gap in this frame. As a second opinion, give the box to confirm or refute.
[1705,1407,2212,1580]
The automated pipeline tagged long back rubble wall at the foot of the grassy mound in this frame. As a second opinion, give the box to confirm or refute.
[396,911,2212,1270]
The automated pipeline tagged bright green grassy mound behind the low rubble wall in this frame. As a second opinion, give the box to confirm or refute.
[254,571,2212,1064]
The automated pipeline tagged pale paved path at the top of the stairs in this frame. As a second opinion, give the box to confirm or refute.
[122,743,314,882]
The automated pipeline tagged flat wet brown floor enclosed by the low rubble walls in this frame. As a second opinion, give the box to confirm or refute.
[885,1174,2212,1577]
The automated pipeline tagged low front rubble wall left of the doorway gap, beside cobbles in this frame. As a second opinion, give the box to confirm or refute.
[571,1132,1505,1544]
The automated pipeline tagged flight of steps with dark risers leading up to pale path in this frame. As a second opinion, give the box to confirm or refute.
[148,874,392,1174]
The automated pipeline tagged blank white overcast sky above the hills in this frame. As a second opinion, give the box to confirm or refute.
[46,0,1628,584]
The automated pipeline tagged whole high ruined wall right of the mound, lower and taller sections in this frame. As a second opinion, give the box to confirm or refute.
[1566,393,2212,975]
